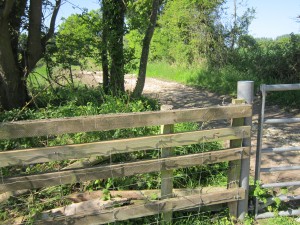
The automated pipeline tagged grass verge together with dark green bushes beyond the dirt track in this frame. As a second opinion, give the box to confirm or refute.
[147,31,300,105]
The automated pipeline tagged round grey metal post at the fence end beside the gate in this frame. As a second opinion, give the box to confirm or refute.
[237,81,254,220]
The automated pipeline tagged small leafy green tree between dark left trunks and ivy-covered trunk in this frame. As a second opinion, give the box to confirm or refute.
[45,10,102,83]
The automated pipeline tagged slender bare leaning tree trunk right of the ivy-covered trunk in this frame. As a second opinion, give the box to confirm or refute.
[132,0,160,97]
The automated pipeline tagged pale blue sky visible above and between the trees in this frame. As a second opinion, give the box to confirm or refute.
[57,0,300,39]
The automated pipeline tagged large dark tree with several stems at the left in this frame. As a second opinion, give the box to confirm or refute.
[0,0,61,110]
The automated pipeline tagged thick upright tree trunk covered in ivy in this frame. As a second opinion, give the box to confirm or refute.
[101,0,126,95]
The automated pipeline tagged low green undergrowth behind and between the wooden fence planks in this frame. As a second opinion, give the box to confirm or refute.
[0,85,227,223]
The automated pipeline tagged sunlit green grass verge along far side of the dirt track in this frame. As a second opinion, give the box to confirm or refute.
[147,62,300,108]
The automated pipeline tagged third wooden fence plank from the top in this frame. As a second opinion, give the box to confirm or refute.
[0,147,250,193]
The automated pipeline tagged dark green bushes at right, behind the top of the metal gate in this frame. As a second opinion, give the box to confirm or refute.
[229,34,300,105]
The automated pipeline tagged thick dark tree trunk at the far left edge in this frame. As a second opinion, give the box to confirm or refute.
[0,17,28,110]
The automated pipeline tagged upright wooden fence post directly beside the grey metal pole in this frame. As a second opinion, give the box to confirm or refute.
[227,99,245,218]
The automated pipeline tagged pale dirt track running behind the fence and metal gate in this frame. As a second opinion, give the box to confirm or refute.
[80,72,300,195]
